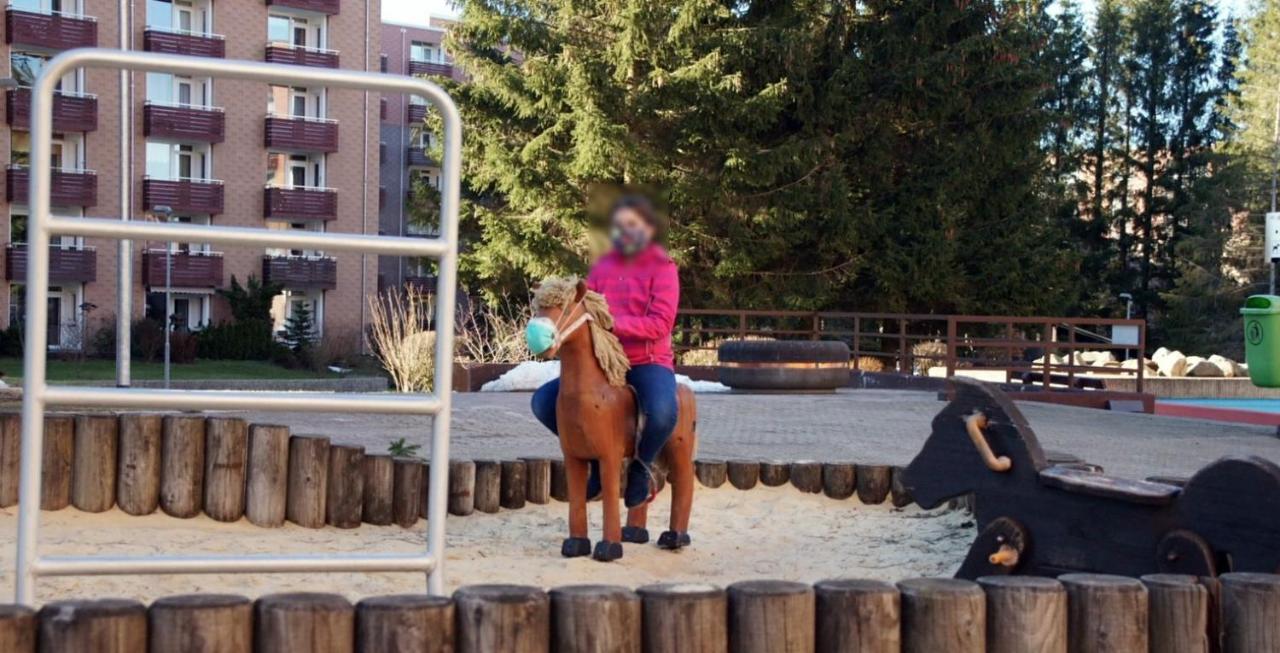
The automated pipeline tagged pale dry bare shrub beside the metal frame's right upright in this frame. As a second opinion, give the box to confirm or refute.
[367,288,435,392]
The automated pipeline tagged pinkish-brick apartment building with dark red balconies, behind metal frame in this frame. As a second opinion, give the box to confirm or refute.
[0,0,396,350]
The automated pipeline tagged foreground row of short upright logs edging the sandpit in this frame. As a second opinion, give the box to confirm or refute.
[0,574,1280,653]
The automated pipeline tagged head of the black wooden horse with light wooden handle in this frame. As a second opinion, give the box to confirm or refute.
[904,378,1047,508]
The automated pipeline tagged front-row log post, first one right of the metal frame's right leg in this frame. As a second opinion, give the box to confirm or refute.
[453,585,550,653]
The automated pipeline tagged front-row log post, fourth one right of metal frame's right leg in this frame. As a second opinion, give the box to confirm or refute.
[728,580,814,653]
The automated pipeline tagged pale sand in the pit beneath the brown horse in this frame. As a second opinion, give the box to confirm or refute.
[0,485,974,602]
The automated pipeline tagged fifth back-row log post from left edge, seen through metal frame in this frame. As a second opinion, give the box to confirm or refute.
[160,415,205,519]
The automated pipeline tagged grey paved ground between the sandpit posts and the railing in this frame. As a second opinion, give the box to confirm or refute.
[230,391,1280,479]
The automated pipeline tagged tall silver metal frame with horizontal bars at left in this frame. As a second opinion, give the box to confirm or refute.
[15,49,462,604]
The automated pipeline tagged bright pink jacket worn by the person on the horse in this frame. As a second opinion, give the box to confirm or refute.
[586,245,680,369]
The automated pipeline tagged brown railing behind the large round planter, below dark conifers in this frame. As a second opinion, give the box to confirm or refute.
[675,309,1147,392]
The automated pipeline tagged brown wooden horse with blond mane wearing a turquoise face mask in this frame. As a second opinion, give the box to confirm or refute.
[532,278,698,562]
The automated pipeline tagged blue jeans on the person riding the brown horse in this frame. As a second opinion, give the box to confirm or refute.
[532,365,677,465]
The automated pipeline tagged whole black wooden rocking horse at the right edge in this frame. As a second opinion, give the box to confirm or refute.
[904,379,1280,579]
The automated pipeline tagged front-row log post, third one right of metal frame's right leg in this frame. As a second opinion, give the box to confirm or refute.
[636,583,728,653]
